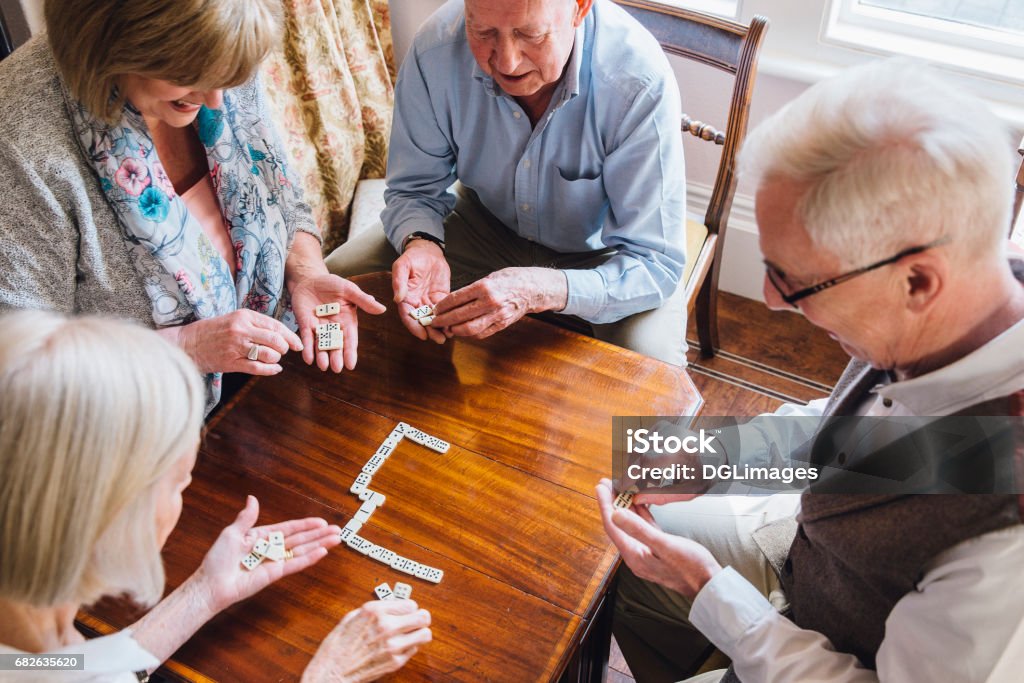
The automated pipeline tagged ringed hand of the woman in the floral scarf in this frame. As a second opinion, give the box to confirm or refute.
[158,308,302,375]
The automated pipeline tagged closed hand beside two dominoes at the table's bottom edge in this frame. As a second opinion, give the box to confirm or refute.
[302,600,431,683]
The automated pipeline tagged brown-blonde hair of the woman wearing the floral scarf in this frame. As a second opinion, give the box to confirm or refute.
[44,0,282,123]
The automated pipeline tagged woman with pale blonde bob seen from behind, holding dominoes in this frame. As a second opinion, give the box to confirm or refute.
[0,311,430,681]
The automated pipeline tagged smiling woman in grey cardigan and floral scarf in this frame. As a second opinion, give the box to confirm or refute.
[0,0,384,411]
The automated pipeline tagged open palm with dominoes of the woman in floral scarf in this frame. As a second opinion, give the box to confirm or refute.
[291,273,386,373]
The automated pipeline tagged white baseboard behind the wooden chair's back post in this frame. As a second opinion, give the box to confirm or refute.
[686,182,764,301]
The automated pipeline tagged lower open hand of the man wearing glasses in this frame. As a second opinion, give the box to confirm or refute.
[597,479,722,600]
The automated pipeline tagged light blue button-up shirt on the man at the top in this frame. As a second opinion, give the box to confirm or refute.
[381,0,686,323]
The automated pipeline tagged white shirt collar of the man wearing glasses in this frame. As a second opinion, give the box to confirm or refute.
[876,321,1024,417]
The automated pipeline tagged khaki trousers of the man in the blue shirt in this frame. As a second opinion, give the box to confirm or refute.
[326,191,687,366]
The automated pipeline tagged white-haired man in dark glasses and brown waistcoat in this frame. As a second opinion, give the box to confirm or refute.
[598,60,1024,683]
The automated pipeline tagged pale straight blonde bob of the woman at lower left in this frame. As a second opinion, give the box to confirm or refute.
[0,311,204,607]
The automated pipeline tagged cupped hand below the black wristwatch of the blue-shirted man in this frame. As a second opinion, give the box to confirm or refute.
[391,240,452,344]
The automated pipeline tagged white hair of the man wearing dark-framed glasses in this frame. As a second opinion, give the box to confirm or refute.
[740,58,1014,267]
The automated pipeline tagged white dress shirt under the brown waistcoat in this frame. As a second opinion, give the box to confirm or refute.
[690,322,1024,683]
